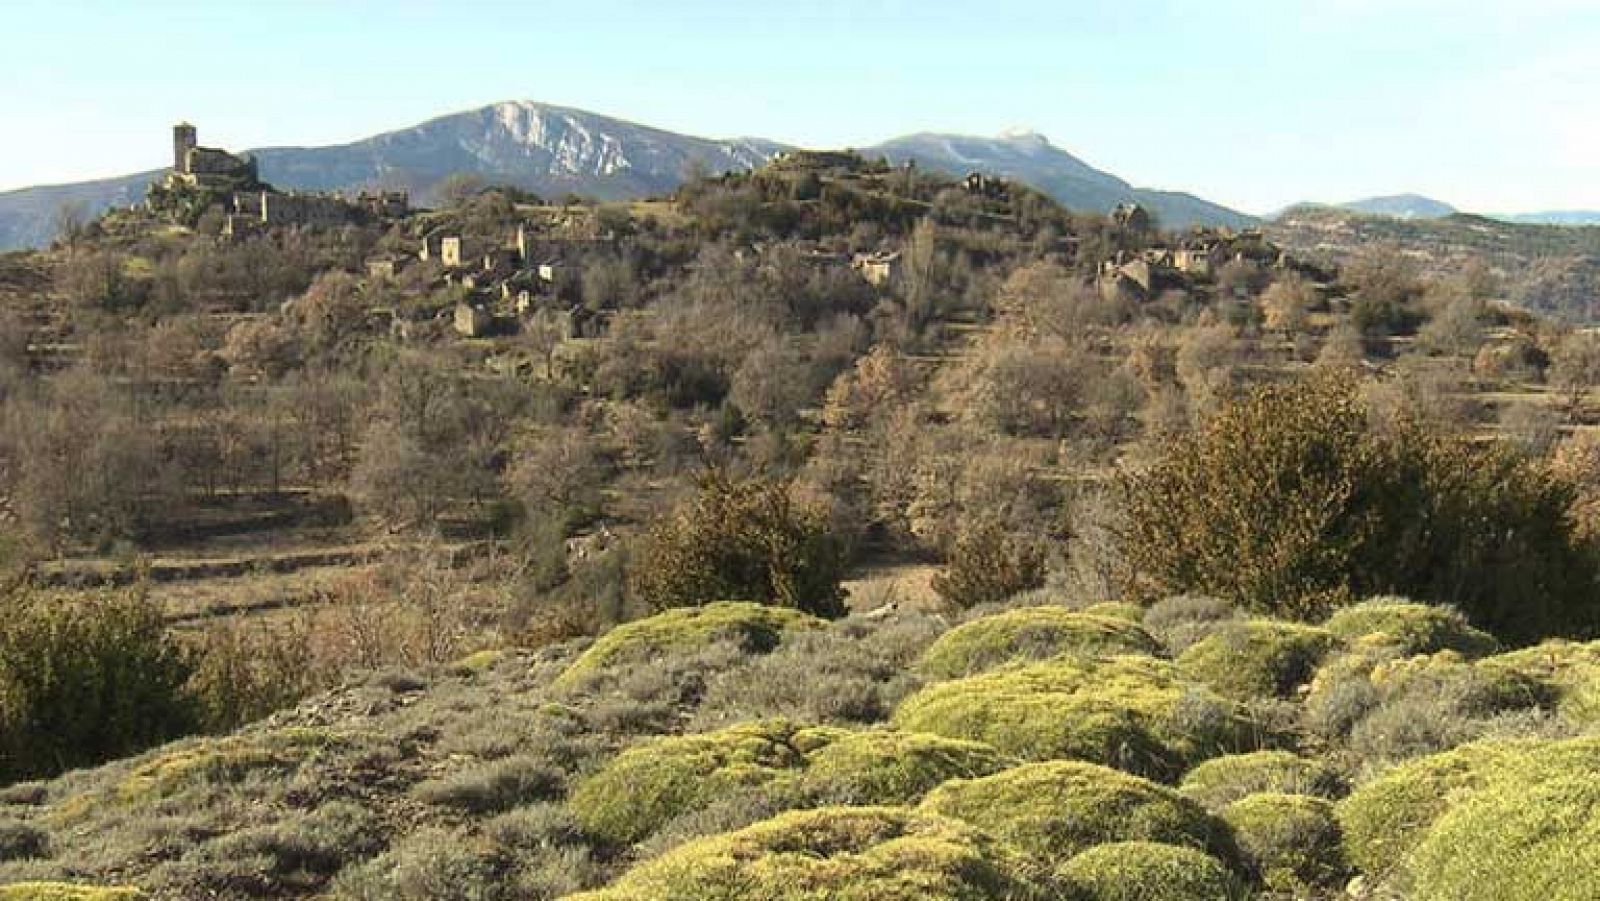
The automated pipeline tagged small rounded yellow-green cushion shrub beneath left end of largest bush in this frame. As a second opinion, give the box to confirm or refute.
[1178,619,1336,701]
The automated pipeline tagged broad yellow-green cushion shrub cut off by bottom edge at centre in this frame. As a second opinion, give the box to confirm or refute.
[571,807,1046,901]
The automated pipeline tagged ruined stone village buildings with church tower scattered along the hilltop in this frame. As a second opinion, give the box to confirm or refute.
[114,123,1333,363]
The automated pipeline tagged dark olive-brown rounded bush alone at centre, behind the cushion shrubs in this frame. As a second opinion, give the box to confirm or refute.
[630,472,846,618]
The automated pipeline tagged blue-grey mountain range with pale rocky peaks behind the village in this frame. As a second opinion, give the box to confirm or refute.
[0,101,1254,250]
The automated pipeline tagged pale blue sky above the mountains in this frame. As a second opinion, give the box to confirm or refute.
[0,0,1600,213]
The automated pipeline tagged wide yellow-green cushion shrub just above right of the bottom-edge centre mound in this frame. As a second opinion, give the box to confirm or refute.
[922,760,1237,861]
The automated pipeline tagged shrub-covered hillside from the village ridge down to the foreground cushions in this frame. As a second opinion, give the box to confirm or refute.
[0,154,1600,901]
